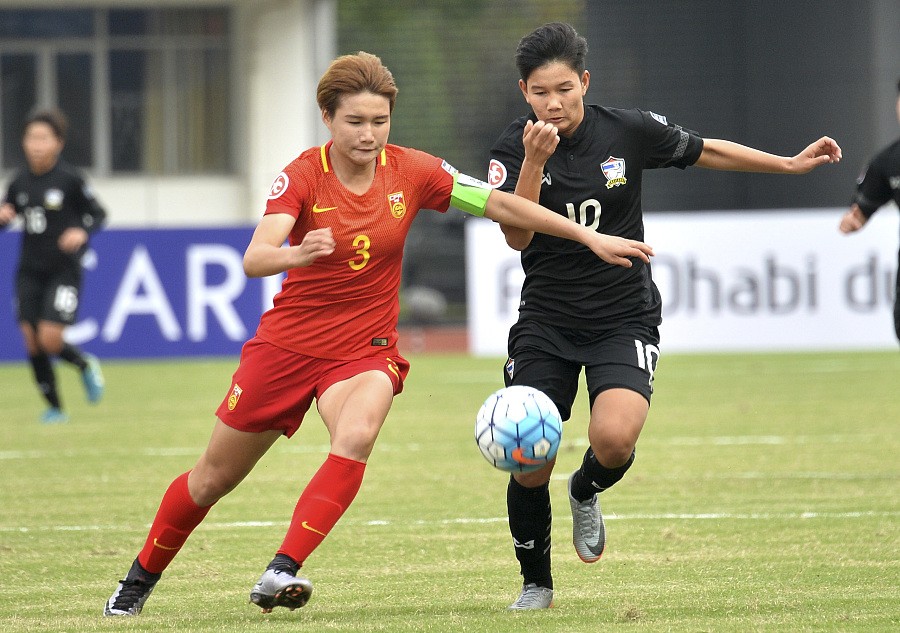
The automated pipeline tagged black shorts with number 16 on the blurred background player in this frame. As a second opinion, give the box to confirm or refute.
[16,267,81,325]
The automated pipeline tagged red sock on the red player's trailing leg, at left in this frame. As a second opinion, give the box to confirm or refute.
[138,471,212,574]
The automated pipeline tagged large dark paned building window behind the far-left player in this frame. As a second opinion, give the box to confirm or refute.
[0,8,233,175]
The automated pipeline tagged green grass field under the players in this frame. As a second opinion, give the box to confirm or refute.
[0,353,900,633]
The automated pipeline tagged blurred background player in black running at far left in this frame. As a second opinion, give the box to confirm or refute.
[0,110,106,423]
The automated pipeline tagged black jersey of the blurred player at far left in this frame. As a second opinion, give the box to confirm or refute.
[6,161,106,271]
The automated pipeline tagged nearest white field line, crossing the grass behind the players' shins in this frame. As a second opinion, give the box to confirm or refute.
[0,511,900,534]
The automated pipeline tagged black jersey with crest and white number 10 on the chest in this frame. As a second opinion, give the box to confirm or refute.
[488,105,703,331]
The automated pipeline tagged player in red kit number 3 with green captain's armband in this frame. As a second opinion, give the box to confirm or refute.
[104,52,651,616]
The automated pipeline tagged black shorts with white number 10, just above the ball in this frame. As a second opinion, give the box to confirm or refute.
[503,321,659,420]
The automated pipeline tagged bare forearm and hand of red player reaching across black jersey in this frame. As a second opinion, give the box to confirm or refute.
[484,190,653,268]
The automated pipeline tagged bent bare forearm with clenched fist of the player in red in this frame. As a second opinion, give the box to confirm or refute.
[244,213,336,277]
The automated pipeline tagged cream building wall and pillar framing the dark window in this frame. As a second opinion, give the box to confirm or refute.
[0,0,336,228]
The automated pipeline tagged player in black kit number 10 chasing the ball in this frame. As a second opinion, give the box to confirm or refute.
[488,23,841,609]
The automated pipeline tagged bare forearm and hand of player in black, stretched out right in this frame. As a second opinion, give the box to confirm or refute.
[696,136,841,174]
